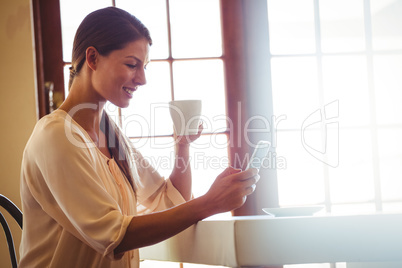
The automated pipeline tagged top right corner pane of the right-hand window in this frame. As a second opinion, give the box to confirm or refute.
[370,0,402,50]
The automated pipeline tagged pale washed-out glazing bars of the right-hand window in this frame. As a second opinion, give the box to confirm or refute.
[266,0,402,214]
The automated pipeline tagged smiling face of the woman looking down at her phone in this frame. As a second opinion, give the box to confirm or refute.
[92,39,149,108]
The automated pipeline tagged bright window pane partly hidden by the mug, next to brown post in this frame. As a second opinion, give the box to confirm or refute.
[173,60,226,133]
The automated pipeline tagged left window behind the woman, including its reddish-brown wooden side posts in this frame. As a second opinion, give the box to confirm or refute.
[37,0,277,218]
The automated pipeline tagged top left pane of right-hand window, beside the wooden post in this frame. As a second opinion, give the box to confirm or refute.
[267,0,315,54]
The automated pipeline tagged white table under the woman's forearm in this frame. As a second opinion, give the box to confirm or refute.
[140,214,402,267]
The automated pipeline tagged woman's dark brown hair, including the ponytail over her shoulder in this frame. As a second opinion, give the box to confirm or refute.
[69,7,152,187]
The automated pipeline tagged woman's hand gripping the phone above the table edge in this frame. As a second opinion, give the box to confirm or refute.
[204,167,260,214]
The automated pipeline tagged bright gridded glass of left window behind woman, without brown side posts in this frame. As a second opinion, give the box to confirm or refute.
[60,0,228,199]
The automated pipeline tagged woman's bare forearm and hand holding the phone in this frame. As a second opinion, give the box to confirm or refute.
[114,168,259,255]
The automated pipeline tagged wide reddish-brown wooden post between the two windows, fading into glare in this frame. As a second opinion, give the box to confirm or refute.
[221,0,278,216]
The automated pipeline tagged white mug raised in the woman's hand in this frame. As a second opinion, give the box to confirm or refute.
[169,100,202,136]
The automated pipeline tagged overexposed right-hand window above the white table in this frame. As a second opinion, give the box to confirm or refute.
[268,0,402,213]
